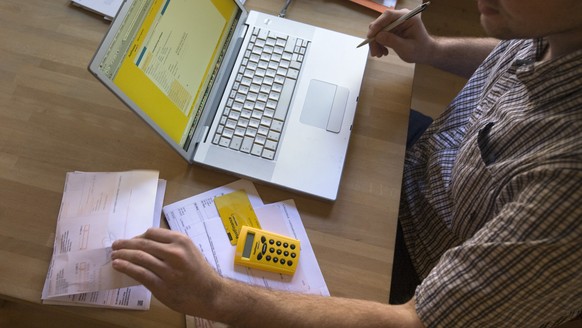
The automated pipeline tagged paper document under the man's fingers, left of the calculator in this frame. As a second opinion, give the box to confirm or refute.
[42,171,166,309]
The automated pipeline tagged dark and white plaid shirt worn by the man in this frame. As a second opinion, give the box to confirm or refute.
[399,40,582,327]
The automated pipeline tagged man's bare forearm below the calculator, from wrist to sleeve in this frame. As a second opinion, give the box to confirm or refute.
[204,281,423,328]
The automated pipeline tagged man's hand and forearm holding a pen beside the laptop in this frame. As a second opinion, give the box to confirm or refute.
[367,10,499,78]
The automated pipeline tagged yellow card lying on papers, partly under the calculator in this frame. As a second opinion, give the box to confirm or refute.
[214,190,261,245]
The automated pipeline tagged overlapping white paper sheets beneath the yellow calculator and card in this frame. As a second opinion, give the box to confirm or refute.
[163,180,329,327]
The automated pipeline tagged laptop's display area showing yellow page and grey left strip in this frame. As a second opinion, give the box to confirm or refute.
[99,0,240,149]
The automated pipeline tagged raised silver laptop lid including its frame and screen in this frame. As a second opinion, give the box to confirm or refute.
[89,0,248,162]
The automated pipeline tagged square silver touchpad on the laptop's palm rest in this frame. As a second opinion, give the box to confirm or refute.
[300,80,350,133]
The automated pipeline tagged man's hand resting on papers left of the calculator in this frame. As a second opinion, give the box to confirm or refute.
[111,228,222,315]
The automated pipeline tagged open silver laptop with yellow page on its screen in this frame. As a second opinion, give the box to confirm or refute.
[89,0,368,201]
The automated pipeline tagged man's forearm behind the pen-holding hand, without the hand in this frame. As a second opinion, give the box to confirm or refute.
[426,37,499,78]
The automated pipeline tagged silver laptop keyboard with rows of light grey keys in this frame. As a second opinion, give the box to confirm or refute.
[212,27,309,159]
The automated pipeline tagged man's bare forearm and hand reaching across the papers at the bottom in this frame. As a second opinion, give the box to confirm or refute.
[112,229,423,327]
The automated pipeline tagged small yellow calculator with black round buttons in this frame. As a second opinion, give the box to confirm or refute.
[234,226,299,275]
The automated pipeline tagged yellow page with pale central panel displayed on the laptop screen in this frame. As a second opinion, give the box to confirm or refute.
[114,0,236,145]
